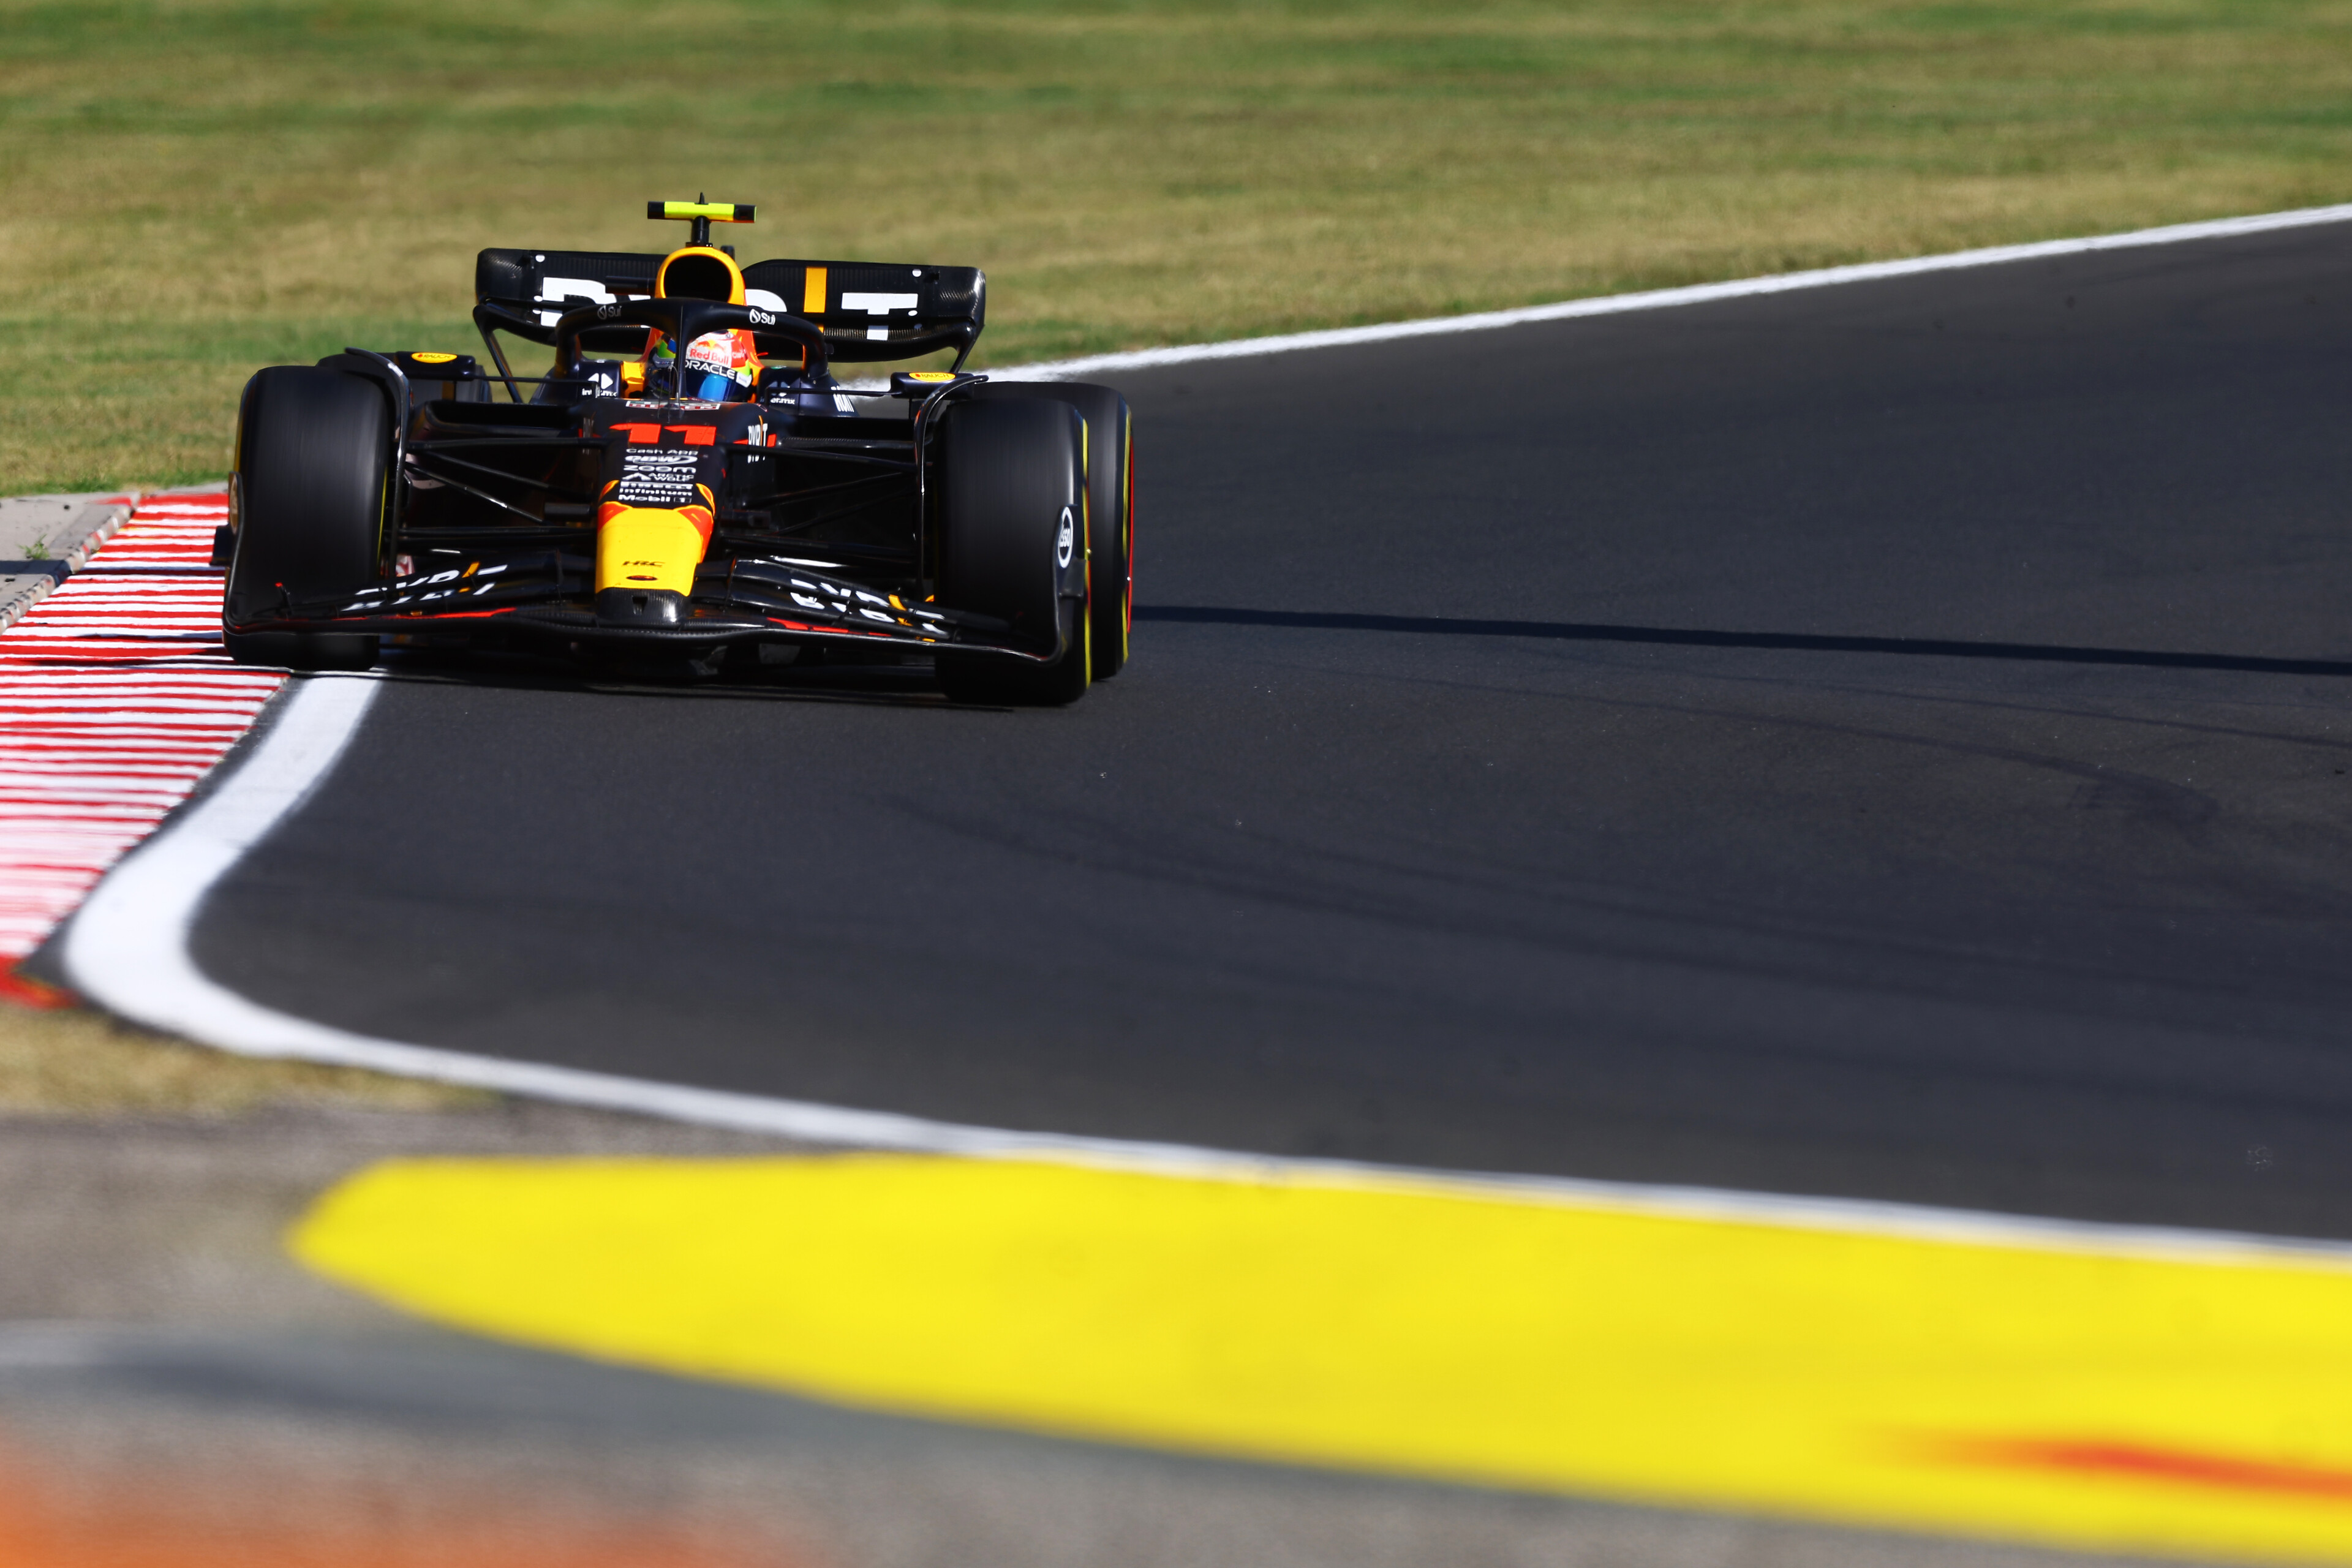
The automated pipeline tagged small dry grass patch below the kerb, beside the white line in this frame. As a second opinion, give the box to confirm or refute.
[0,1004,496,1117]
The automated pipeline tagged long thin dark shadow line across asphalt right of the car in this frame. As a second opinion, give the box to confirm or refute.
[1136,604,2352,675]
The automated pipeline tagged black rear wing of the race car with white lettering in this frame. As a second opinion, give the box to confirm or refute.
[473,249,988,367]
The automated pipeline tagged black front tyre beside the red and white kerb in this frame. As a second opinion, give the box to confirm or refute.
[221,364,393,670]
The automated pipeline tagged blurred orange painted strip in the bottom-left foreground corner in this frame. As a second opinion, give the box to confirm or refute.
[0,1455,809,1568]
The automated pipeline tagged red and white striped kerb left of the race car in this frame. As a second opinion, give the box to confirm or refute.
[0,494,287,1001]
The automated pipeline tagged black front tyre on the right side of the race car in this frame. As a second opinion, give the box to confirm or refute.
[933,398,1094,705]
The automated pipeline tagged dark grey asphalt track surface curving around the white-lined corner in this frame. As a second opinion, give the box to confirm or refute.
[195,225,2352,1237]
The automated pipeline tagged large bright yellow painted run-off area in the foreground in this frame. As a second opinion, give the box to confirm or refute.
[292,1154,2352,1561]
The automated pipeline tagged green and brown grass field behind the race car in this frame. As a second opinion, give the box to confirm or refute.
[0,0,2352,494]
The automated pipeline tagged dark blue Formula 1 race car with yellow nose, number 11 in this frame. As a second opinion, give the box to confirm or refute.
[214,202,1134,703]
